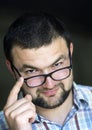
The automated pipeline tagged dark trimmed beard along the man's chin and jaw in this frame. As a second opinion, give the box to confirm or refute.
[32,83,72,109]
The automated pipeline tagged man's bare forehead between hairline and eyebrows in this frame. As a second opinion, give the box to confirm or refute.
[12,38,68,68]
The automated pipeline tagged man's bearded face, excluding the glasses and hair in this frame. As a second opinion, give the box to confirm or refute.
[12,38,73,108]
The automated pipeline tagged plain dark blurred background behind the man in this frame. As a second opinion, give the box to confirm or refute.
[0,0,92,109]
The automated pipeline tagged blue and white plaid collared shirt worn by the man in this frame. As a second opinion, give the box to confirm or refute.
[0,83,92,130]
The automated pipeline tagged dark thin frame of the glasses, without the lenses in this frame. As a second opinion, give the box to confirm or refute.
[11,50,72,88]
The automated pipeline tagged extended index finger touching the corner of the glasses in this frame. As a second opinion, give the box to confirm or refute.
[6,77,24,107]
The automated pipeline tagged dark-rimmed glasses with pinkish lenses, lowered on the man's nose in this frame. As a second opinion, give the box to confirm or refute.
[11,51,72,88]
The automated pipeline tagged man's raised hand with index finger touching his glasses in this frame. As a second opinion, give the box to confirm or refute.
[4,77,36,130]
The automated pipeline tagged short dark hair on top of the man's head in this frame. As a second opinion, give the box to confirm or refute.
[4,12,71,61]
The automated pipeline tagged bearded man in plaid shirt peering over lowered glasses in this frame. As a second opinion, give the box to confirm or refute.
[0,13,92,130]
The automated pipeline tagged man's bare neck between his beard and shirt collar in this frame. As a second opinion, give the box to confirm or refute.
[36,91,73,125]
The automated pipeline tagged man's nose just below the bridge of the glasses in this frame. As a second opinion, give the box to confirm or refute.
[43,77,57,89]
